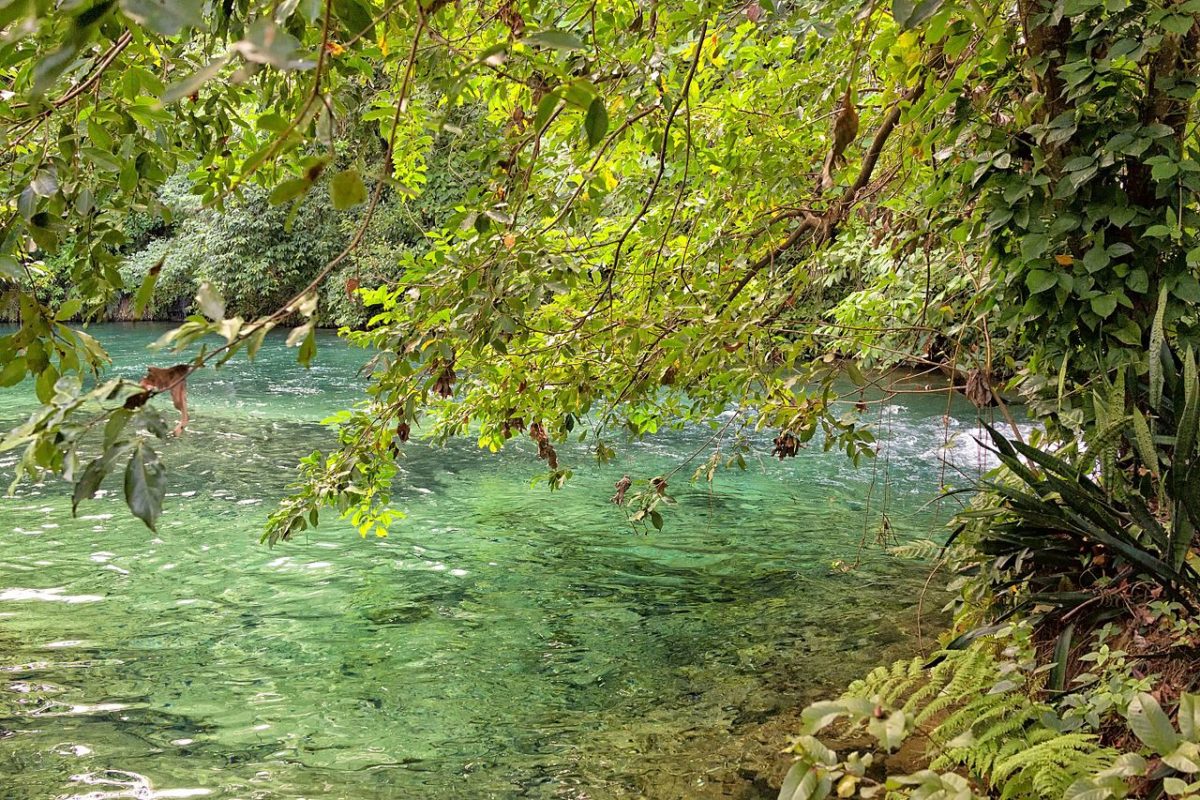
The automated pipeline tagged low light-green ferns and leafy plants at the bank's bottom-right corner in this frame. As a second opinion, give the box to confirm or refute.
[779,626,1200,800]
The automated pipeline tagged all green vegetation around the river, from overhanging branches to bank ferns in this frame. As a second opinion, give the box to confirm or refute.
[0,0,1200,800]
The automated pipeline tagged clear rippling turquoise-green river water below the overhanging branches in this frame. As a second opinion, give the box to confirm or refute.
[0,325,979,800]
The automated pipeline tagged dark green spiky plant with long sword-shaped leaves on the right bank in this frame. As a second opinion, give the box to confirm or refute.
[950,345,1200,636]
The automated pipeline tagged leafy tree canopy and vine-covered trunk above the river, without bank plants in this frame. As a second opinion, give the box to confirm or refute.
[0,0,1200,541]
